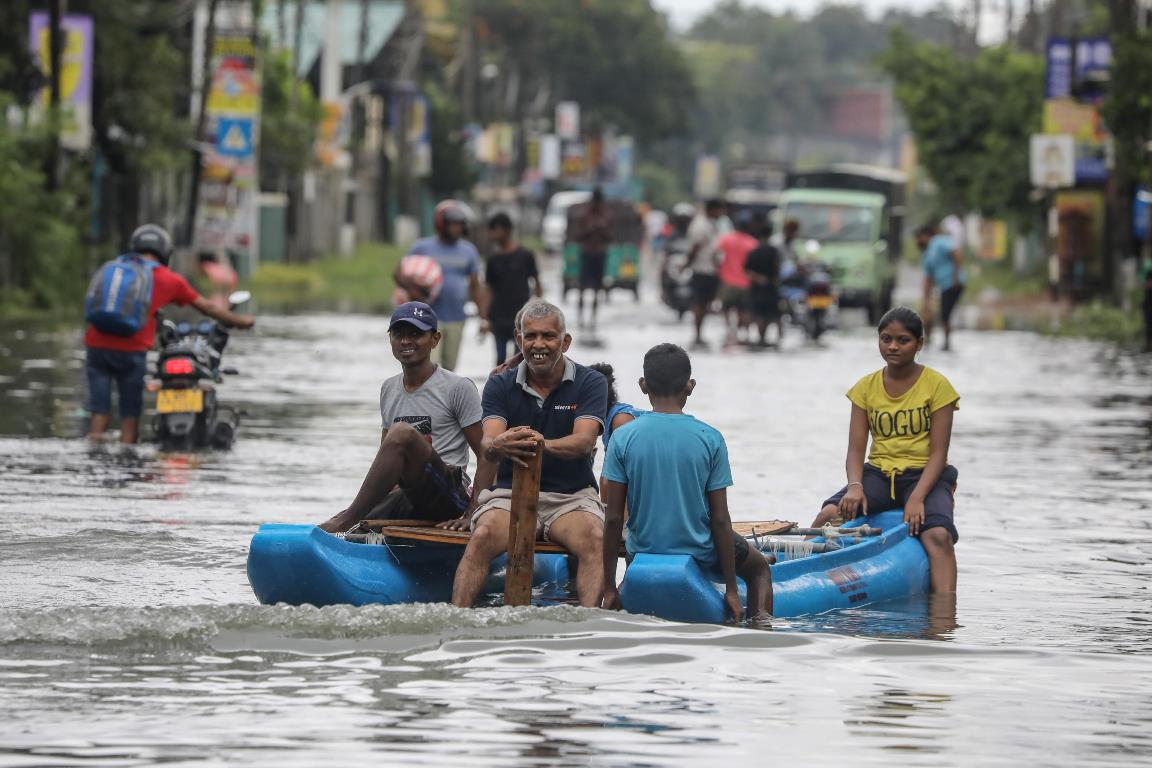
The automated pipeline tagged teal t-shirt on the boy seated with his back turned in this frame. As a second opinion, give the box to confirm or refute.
[604,413,732,567]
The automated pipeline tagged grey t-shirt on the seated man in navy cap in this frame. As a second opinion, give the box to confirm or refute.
[380,366,484,470]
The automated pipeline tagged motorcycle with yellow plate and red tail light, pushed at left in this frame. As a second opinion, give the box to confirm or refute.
[152,290,251,450]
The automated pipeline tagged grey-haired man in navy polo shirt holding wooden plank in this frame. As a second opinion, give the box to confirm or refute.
[452,301,608,607]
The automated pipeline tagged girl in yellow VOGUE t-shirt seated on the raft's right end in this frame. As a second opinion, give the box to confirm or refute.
[813,306,960,592]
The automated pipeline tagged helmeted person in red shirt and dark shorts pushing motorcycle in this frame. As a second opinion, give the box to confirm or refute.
[84,225,256,443]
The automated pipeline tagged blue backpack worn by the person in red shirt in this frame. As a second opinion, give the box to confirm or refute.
[84,253,158,336]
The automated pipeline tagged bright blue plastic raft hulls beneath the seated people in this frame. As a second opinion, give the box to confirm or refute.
[248,510,929,623]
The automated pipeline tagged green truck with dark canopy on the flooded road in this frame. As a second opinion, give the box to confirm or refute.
[776,164,907,324]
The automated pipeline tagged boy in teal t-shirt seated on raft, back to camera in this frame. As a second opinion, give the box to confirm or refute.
[600,344,772,621]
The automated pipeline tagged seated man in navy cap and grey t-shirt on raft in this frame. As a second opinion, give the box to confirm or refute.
[320,302,495,533]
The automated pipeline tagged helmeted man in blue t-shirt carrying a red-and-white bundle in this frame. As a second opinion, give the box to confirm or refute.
[392,200,484,371]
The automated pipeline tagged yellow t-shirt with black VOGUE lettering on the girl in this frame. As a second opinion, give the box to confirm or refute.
[848,366,960,474]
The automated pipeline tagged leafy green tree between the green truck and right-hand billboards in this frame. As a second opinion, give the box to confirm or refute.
[881,30,1044,219]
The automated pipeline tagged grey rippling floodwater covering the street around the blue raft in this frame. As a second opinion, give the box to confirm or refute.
[0,277,1152,767]
